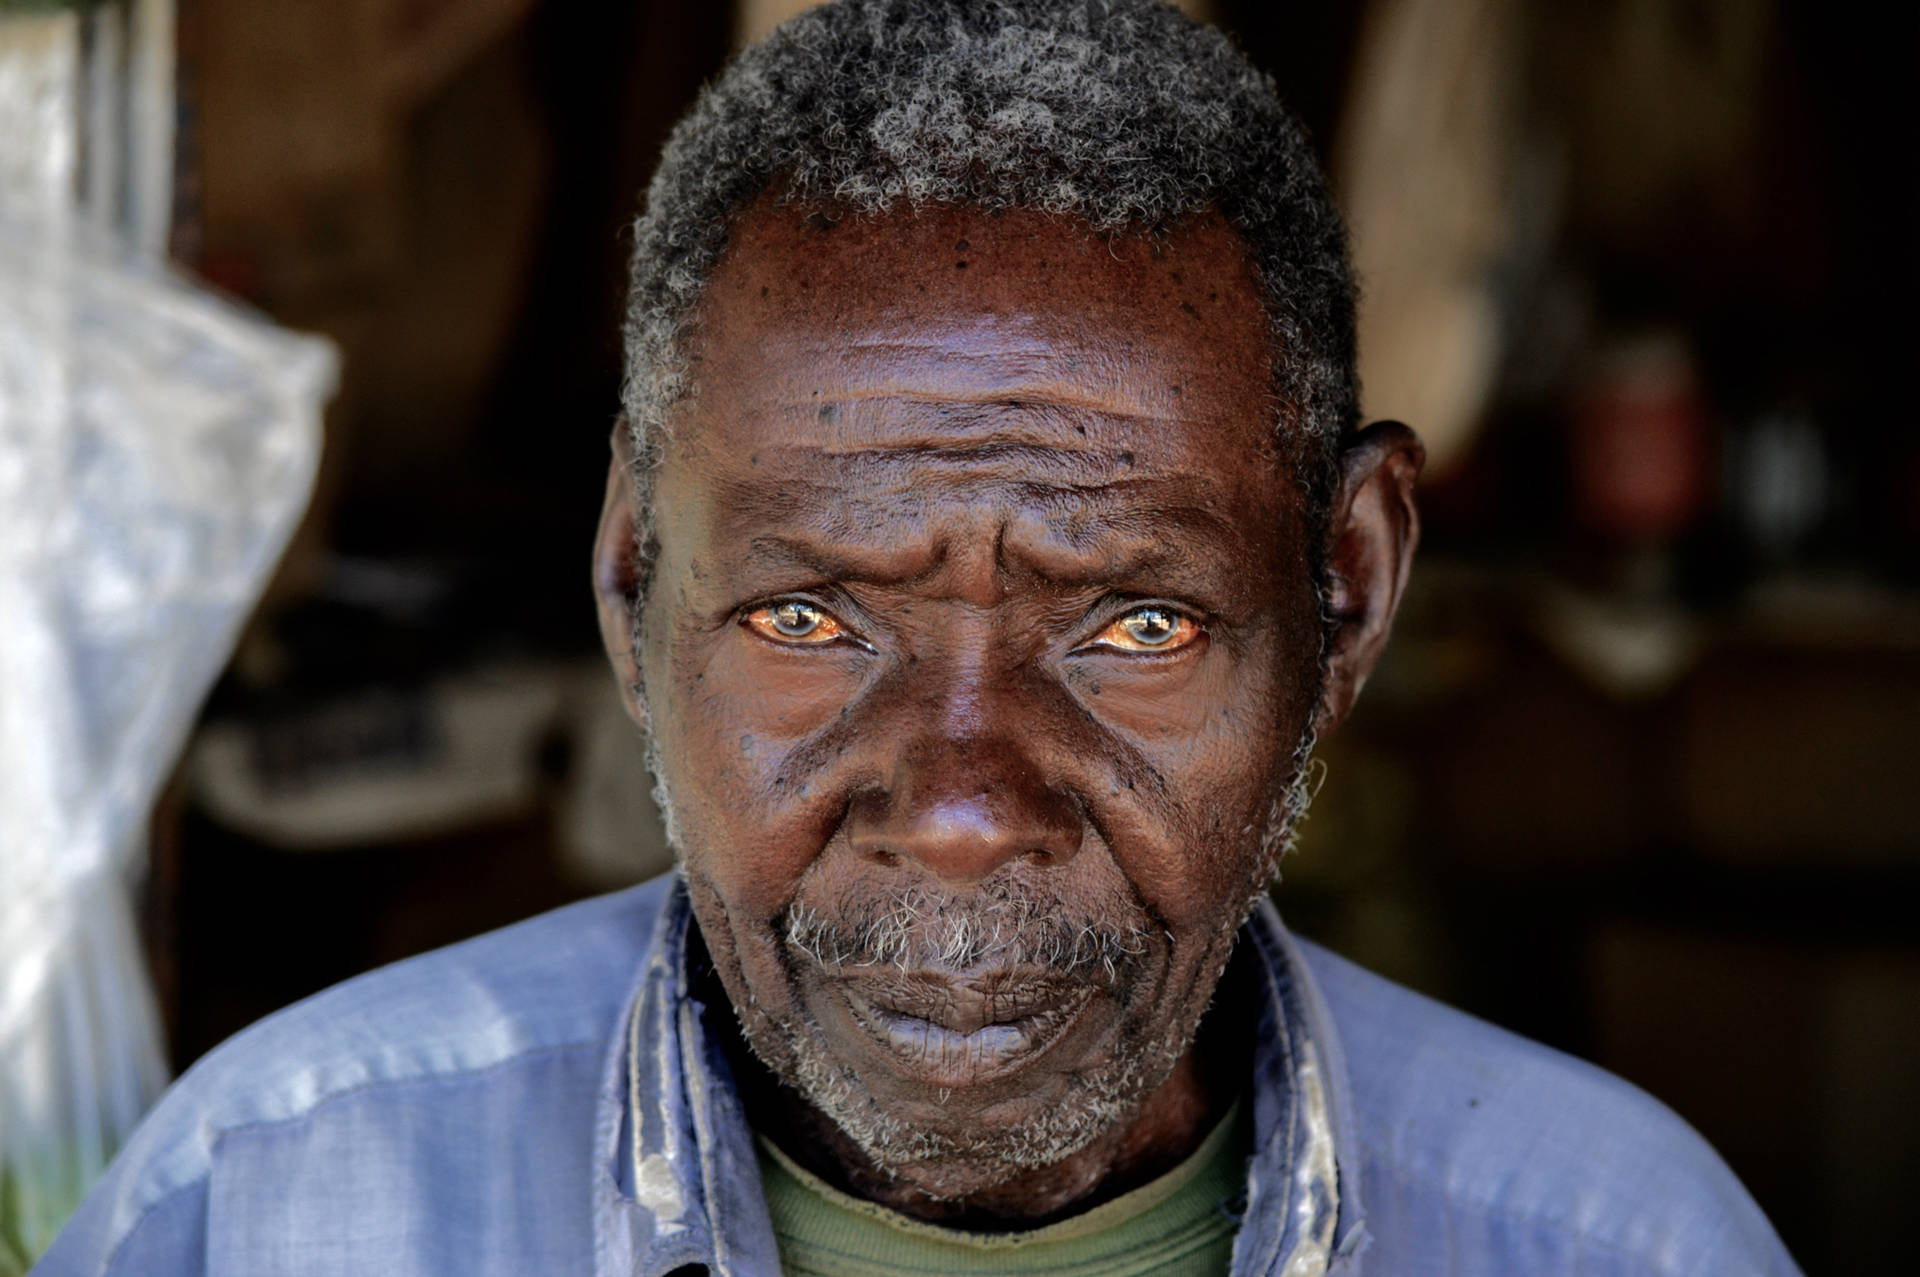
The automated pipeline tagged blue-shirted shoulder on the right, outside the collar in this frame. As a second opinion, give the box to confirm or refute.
[1300,943,1797,1277]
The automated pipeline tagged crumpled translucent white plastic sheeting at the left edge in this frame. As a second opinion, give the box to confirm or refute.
[0,214,334,1273]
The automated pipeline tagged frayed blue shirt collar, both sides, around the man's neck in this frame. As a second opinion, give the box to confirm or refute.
[593,874,1365,1277]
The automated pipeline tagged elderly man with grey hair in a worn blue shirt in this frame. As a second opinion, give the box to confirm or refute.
[42,0,1793,1277]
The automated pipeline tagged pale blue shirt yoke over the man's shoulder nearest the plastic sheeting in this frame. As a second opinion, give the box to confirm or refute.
[36,878,672,1273]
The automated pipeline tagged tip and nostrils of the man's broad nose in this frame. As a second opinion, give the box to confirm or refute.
[849,735,1081,887]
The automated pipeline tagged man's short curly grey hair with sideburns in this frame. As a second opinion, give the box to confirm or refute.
[622,0,1357,584]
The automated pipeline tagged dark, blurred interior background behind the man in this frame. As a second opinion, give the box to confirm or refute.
[146,0,1920,1273]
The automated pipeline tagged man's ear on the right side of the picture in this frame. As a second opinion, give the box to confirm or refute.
[1313,421,1427,735]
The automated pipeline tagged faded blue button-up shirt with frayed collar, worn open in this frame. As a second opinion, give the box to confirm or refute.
[33,876,1797,1277]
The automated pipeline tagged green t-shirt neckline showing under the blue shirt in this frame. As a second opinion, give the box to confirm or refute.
[760,1104,1250,1277]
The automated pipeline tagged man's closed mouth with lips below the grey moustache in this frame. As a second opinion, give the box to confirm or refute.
[841,970,1094,1091]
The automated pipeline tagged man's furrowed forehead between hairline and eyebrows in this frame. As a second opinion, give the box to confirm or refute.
[660,200,1292,583]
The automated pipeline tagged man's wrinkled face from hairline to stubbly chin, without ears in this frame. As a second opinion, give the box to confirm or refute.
[639,202,1321,1196]
